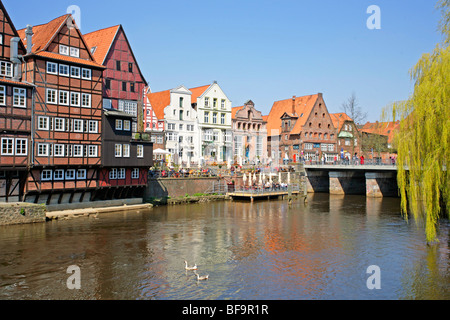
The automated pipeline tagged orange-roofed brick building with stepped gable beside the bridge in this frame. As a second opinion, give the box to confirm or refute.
[267,93,337,165]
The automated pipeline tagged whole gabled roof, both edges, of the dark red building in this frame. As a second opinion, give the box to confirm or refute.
[84,24,148,85]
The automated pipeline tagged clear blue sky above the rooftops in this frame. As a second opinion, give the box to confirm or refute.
[3,0,440,121]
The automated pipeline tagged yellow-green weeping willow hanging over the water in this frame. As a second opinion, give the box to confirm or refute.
[383,0,450,242]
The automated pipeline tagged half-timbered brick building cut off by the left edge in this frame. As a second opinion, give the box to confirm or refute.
[0,1,33,202]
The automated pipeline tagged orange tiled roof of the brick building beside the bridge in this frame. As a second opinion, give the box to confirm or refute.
[267,94,319,136]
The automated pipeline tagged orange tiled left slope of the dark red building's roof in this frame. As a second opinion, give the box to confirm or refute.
[84,25,120,64]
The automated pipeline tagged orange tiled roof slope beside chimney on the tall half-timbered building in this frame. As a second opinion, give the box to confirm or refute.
[17,14,71,53]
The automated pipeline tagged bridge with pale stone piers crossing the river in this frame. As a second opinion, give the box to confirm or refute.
[305,165,399,198]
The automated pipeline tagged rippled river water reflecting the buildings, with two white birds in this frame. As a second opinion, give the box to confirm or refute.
[0,194,450,300]
